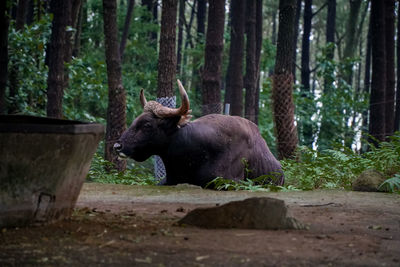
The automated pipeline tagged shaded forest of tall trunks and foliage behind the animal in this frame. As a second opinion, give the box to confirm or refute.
[0,0,400,191]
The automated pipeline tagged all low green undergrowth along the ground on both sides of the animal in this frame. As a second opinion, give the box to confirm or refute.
[88,132,400,192]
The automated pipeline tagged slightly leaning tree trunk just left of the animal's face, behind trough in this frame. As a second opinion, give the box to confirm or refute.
[103,0,126,171]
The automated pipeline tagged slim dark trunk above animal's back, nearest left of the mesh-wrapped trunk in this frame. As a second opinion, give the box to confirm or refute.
[244,0,258,122]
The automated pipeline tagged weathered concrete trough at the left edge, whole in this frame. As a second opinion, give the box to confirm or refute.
[0,115,104,227]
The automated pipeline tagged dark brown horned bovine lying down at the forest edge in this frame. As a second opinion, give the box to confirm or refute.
[114,80,284,187]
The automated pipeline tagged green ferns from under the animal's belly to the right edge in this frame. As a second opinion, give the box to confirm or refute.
[207,132,400,192]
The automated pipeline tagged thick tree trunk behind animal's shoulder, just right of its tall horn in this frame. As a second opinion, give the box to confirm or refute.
[202,0,225,115]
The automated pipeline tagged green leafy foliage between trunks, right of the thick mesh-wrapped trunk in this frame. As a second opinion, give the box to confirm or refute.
[316,44,369,150]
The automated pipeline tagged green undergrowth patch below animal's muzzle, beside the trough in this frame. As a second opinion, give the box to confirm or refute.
[87,153,157,185]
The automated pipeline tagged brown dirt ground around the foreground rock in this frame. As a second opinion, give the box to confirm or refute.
[0,183,400,266]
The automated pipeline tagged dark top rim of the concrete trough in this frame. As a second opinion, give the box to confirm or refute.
[0,115,105,134]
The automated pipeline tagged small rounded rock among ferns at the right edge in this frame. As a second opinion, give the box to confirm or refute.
[352,170,386,192]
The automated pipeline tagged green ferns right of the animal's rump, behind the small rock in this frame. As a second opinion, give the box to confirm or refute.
[281,132,400,190]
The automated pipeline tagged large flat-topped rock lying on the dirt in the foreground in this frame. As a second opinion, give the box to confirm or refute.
[178,197,304,230]
